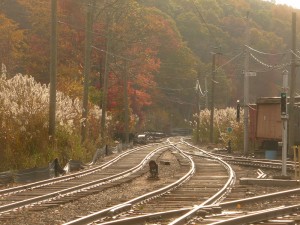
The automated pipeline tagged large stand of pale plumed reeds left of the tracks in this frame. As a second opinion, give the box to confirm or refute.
[0,73,101,170]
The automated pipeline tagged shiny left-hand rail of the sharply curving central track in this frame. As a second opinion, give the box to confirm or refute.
[64,143,195,225]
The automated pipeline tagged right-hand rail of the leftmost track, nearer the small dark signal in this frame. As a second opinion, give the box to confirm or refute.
[0,145,170,213]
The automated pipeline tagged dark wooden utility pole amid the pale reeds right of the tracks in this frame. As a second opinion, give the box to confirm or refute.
[209,53,217,143]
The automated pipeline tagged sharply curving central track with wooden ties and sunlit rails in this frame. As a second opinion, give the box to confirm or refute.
[61,140,235,225]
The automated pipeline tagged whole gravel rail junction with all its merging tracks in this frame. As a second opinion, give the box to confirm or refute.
[0,138,300,225]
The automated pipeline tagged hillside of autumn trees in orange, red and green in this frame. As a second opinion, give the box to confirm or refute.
[0,0,300,171]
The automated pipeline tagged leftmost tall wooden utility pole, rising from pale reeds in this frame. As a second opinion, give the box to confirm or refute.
[49,0,57,140]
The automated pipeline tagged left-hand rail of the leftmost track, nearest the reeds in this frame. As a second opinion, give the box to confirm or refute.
[0,144,156,197]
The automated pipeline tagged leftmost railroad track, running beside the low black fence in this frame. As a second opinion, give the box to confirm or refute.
[0,144,169,220]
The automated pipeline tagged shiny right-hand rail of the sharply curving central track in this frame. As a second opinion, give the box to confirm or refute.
[169,139,236,225]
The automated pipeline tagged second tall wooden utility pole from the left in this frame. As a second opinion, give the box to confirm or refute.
[81,0,95,143]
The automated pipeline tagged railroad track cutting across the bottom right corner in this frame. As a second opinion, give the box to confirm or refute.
[191,188,300,225]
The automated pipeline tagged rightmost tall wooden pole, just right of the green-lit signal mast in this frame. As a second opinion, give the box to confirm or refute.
[288,12,297,155]
